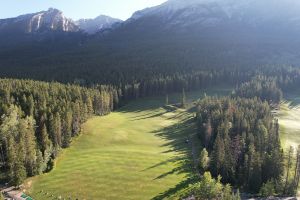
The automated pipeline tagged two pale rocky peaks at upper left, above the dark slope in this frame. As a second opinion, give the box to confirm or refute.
[0,8,122,34]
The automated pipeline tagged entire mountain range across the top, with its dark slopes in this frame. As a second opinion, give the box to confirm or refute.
[0,0,300,82]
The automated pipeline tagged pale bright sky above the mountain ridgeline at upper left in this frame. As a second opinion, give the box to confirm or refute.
[0,0,166,20]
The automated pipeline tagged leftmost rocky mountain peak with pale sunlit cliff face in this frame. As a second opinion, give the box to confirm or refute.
[0,8,79,33]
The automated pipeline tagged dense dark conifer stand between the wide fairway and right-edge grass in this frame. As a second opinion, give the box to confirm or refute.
[197,97,283,193]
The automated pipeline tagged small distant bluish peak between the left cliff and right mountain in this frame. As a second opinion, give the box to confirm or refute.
[76,15,122,34]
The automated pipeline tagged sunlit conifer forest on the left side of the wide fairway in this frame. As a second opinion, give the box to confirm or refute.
[0,79,119,185]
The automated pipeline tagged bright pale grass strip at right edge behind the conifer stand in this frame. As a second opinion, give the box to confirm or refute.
[277,93,300,150]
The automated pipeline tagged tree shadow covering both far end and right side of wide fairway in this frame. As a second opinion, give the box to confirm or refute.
[119,97,200,200]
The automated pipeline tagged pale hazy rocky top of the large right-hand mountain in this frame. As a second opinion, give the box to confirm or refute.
[131,0,300,30]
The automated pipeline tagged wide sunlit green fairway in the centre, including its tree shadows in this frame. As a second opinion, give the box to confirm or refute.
[26,90,230,200]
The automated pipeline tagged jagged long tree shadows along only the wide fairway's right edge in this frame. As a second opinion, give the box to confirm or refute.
[149,112,200,200]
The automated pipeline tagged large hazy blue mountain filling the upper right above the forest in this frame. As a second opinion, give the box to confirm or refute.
[99,0,300,68]
